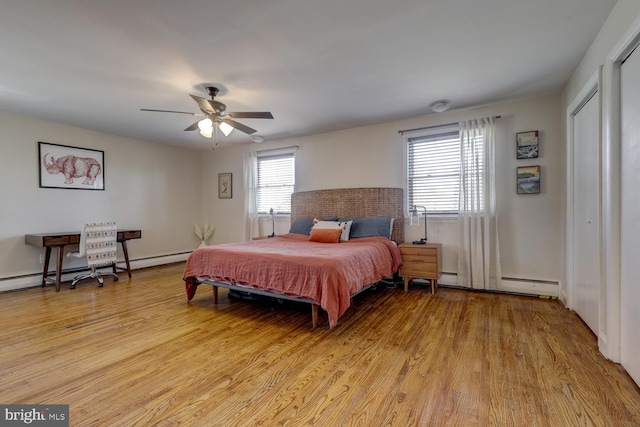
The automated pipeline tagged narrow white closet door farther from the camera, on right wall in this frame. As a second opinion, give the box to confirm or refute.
[573,93,600,335]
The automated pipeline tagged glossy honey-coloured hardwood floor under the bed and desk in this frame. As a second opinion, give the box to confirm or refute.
[0,264,640,426]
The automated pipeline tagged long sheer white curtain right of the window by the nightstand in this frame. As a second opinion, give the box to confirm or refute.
[457,117,502,289]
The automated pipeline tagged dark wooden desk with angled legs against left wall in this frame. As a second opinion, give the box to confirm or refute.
[24,230,142,292]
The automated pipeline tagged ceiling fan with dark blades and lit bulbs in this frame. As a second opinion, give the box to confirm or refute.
[140,86,273,138]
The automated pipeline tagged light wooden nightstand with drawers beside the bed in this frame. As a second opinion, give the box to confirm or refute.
[398,243,442,294]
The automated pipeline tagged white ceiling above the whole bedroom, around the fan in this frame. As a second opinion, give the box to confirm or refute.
[0,0,616,150]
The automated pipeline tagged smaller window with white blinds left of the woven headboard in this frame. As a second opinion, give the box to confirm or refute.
[256,150,295,214]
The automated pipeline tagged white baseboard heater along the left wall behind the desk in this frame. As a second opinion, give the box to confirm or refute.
[0,252,191,292]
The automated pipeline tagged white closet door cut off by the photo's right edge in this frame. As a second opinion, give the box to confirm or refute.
[620,44,640,384]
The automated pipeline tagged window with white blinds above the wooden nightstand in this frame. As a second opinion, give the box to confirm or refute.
[404,126,460,214]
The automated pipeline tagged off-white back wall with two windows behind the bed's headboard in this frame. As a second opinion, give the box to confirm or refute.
[202,96,564,290]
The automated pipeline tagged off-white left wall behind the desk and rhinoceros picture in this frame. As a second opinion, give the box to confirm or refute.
[0,112,202,290]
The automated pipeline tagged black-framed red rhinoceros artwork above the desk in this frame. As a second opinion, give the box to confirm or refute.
[38,142,104,190]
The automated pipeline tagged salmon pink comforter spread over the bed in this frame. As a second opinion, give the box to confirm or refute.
[183,233,402,328]
